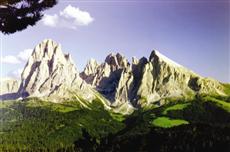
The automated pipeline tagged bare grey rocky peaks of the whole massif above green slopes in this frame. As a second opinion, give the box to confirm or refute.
[2,39,224,112]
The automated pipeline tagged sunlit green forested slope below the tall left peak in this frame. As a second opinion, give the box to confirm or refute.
[0,99,124,151]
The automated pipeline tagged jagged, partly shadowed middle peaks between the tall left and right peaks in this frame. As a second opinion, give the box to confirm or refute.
[81,53,129,102]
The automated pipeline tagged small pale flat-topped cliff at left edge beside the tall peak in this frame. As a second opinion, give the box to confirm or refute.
[0,78,20,95]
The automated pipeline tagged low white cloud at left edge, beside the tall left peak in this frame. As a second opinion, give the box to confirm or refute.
[0,49,33,64]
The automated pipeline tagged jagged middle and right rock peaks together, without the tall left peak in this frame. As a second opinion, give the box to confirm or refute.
[81,50,223,107]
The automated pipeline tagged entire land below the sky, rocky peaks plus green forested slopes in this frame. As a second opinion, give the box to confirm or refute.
[0,39,230,152]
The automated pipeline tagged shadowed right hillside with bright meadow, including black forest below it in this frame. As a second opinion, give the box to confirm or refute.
[91,96,230,152]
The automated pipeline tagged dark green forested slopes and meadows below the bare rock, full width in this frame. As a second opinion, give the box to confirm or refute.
[0,93,230,152]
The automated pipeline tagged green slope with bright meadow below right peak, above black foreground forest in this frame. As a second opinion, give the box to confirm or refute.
[113,96,230,136]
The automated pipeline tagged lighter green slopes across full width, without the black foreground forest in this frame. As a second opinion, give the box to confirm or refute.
[0,91,230,151]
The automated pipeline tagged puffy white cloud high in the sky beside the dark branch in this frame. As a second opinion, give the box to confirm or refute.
[42,5,94,29]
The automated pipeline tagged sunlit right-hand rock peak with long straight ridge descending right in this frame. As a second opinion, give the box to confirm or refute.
[137,51,222,102]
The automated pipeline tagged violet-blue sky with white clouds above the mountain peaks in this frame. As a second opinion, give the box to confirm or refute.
[2,0,230,82]
